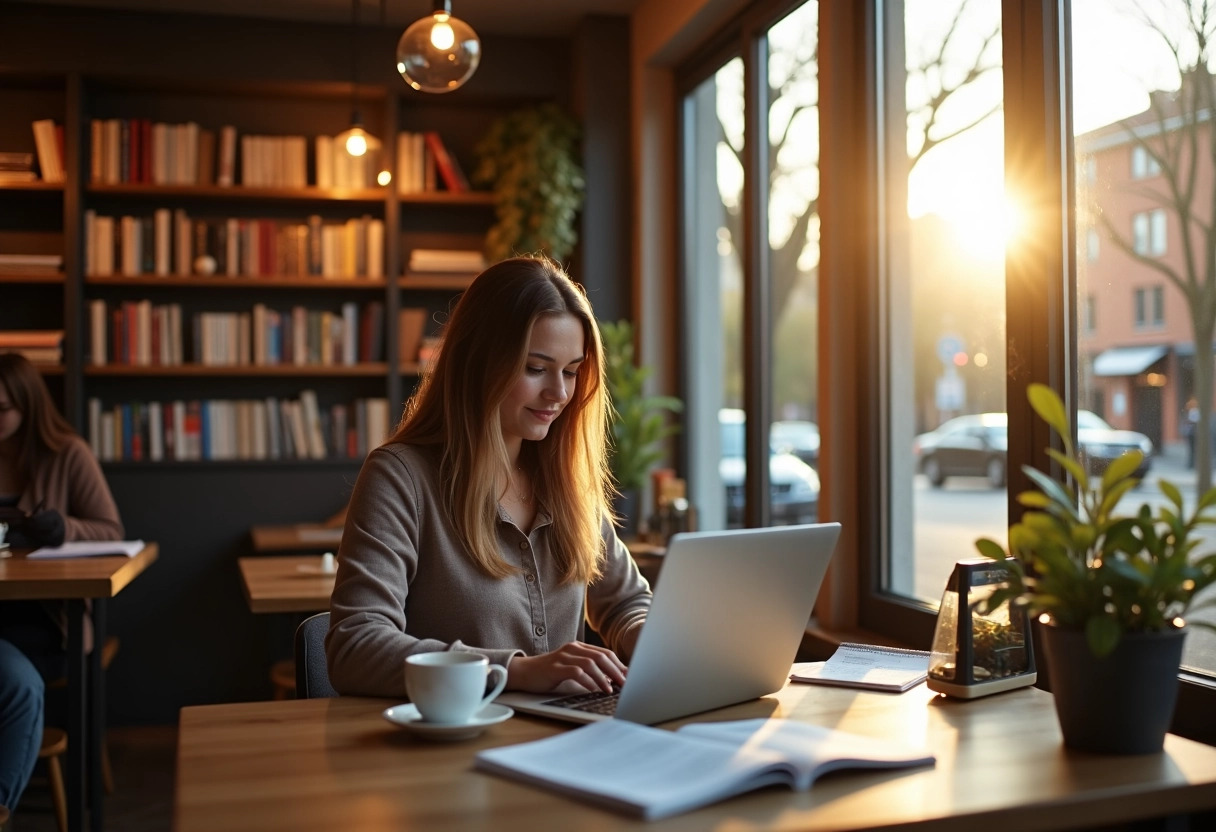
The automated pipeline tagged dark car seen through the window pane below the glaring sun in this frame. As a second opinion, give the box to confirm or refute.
[912,414,1009,488]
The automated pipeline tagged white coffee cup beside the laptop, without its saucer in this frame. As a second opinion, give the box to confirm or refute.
[405,651,507,725]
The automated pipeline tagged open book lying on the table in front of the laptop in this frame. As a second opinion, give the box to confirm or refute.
[473,719,935,820]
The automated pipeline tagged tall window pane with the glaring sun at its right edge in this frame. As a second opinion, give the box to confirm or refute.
[883,0,1001,603]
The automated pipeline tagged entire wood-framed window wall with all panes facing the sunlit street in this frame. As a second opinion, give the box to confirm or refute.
[679,0,1216,734]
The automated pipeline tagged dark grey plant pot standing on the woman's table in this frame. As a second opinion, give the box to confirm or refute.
[1042,624,1187,754]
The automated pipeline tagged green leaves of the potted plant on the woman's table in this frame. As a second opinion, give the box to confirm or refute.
[975,384,1216,657]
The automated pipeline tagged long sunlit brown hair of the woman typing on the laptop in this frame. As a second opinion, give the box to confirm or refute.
[390,257,609,583]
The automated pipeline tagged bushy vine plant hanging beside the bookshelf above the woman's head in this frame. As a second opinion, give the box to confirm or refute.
[473,103,585,263]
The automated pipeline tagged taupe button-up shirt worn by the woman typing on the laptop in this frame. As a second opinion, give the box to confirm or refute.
[326,444,651,697]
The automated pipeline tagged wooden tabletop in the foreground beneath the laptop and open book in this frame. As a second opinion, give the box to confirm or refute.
[174,685,1216,832]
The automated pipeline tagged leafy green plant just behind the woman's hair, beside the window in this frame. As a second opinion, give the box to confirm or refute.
[599,321,683,489]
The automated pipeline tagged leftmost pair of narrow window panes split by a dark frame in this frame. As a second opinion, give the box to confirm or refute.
[681,2,820,529]
